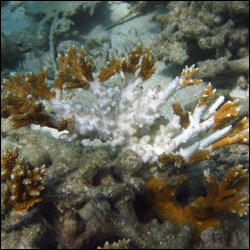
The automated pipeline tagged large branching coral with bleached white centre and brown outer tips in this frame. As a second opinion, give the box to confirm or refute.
[1,45,248,166]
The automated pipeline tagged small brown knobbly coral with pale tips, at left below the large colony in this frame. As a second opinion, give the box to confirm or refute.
[1,150,45,213]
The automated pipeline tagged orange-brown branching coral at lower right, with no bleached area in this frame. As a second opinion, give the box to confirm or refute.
[145,165,249,236]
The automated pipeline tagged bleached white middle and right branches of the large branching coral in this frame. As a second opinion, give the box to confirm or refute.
[47,60,248,163]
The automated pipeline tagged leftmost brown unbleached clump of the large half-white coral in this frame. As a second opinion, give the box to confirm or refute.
[1,71,67,131]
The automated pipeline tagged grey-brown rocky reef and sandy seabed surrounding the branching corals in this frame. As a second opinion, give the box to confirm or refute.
[1,1,249,249]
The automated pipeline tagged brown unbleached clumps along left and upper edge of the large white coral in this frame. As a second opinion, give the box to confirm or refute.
[1,45,155,131]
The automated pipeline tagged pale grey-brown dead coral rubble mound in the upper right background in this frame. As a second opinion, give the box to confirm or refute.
[154,1,249,78]
